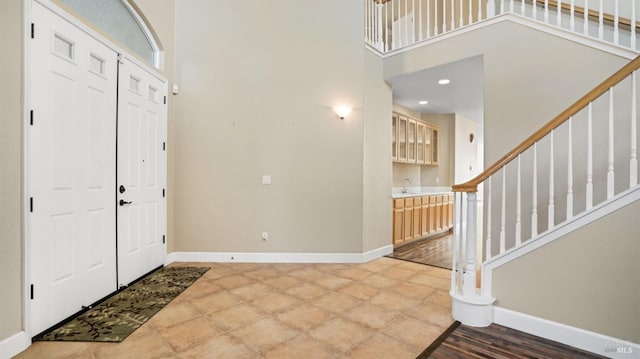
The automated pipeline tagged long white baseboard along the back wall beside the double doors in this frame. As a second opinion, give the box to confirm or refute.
[165,244,393,264]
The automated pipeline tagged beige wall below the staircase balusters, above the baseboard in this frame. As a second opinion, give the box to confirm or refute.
[492,202,640,345]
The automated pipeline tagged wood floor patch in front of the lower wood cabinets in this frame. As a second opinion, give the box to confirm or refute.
[388,234,453,269]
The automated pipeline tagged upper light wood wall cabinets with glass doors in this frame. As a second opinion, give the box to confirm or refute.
[391,113,440,165]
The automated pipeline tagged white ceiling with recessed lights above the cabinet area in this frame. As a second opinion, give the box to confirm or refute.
[387,56,484,124]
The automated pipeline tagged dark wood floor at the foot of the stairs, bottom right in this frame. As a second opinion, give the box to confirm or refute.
[418,322,603,359]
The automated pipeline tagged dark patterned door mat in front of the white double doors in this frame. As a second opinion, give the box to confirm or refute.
[33,267,209,342]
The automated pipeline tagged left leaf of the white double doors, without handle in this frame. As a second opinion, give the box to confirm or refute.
[26,2,117,334]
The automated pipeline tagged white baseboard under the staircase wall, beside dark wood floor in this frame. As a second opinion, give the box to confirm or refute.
[493,307,640,359]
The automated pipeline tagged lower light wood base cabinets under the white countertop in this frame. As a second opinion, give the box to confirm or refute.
[393,194,453,246]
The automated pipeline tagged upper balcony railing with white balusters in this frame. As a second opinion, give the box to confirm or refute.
[364,0,640,53]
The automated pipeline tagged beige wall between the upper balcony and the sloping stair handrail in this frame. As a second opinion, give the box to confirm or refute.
[384,22,628,166]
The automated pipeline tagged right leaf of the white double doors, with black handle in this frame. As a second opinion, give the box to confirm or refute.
[117,57,167,286]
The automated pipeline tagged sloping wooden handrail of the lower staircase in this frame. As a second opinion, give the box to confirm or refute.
[452,56,640,192]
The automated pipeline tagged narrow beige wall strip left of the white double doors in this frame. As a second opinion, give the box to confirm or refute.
[0,0,23,341]
